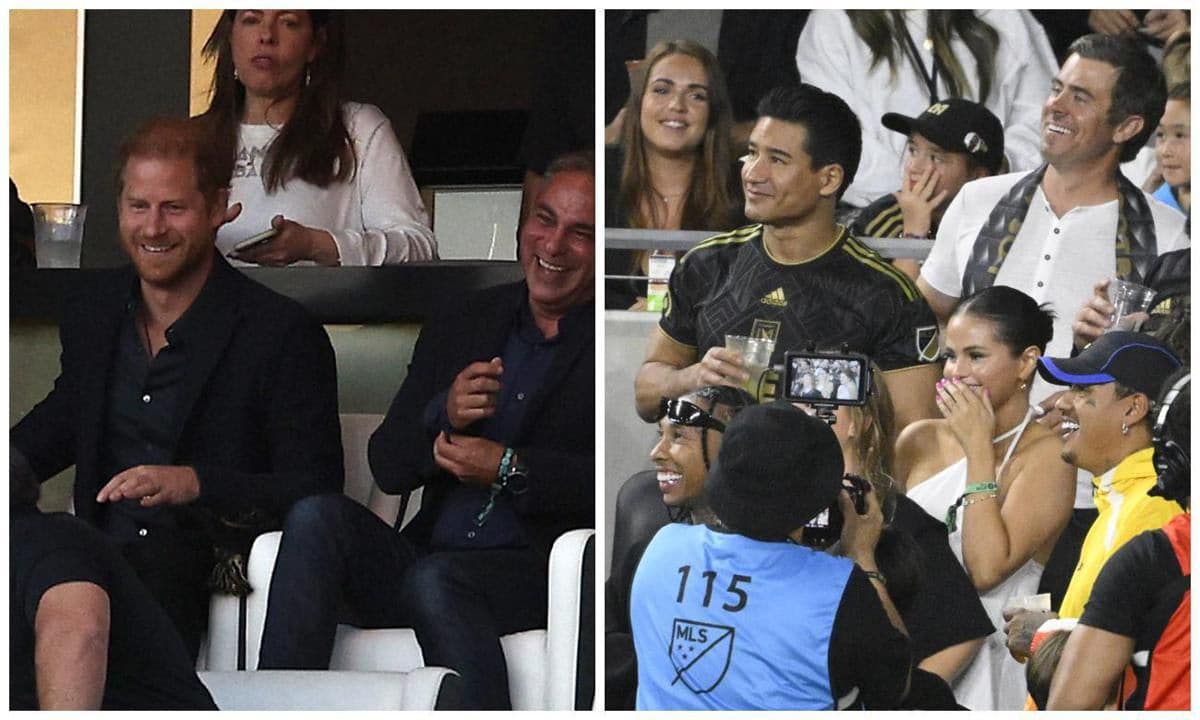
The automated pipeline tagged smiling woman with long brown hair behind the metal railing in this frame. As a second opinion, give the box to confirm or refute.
[605,40,742,308]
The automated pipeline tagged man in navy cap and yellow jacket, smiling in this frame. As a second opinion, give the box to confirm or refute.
[1006,331,1182,655]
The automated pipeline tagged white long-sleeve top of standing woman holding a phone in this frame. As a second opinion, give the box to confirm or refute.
[217,102,437,265]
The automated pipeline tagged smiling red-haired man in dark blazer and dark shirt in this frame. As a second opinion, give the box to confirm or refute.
[10,118,343,659]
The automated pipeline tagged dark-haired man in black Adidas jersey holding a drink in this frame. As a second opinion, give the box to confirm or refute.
[635,85,938,427]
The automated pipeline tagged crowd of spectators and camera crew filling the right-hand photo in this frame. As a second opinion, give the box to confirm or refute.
[605,10,1190,710]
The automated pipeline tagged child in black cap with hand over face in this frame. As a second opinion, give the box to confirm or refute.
[851,97,1004,278]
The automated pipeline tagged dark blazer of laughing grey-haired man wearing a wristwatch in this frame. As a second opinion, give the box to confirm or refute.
[368,282,595,554]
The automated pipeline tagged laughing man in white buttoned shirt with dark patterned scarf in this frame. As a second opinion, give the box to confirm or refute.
[917,35,1189,401]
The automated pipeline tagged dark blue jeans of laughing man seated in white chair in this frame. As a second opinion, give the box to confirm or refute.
[258,494,547,709]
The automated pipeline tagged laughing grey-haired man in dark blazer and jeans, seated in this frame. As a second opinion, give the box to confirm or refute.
[259,154,595,709]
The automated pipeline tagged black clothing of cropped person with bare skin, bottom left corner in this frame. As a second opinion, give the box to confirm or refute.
[8,509,216,710]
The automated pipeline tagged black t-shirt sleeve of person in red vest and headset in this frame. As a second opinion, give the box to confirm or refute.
[1079,518,1190,709]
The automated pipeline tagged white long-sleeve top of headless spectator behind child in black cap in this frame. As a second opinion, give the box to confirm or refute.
[796,10,1058,206]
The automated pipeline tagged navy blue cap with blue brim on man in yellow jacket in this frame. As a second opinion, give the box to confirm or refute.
[1038,331,1183,397]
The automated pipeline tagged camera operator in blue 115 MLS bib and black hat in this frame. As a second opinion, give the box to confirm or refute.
[630,402,911,709]
